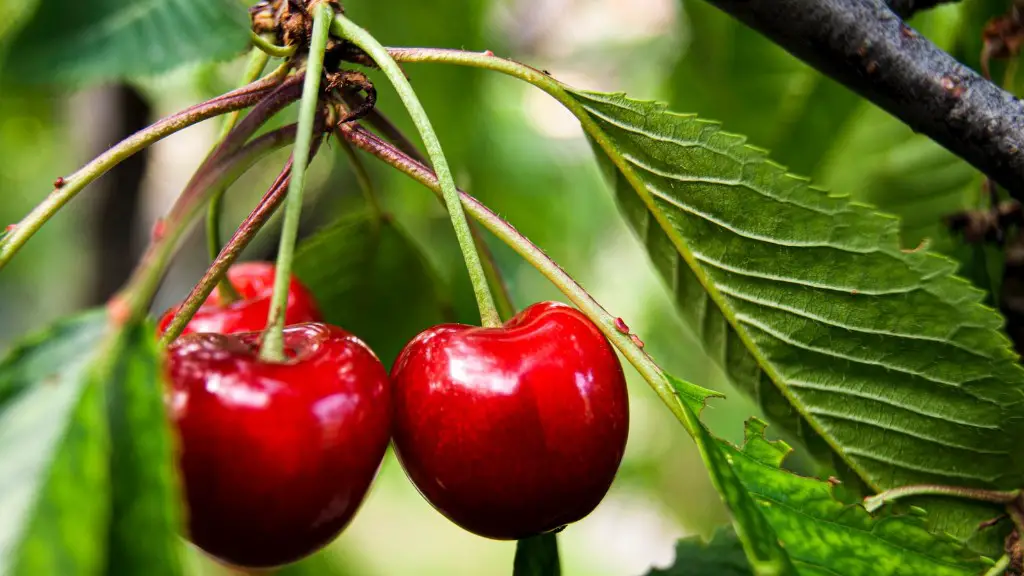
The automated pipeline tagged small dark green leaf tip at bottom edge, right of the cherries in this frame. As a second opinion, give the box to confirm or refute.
[646,528,753,576]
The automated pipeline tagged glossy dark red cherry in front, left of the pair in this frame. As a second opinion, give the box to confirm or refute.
[167,323,391,567]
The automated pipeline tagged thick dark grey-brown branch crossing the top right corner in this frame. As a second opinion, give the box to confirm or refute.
[708,0,1024,199]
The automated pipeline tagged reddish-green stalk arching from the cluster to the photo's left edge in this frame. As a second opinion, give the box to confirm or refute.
[0,77,280,269]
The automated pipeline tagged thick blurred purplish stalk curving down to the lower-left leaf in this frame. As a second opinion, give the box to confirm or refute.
[115,119,295,317]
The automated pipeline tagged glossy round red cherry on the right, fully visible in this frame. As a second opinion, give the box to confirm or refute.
[391,302,629,539]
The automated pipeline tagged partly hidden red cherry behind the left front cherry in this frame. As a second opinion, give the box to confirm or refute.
[159,262,322,335]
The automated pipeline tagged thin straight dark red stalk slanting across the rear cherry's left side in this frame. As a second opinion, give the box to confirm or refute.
[160,140,313,345]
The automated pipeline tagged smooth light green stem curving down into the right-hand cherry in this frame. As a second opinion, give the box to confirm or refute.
[332,14,502,326]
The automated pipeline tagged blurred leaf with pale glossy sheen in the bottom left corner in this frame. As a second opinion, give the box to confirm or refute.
[0,311,110,576]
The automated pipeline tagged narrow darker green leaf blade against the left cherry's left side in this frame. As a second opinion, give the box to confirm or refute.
[92,315,182,576]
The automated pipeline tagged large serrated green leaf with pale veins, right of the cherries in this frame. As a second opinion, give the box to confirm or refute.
[572,87,1024,538]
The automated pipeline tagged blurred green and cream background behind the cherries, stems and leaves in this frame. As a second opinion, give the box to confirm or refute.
[0,0,1013,576]
